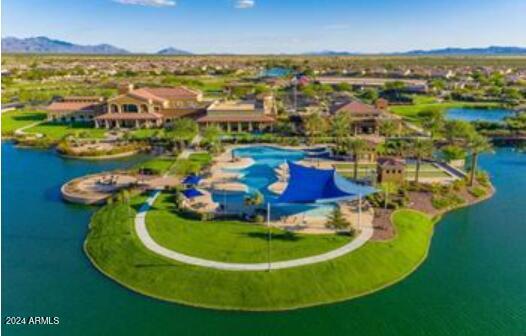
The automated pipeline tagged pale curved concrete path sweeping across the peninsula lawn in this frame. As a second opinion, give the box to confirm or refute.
[135,191,373,271]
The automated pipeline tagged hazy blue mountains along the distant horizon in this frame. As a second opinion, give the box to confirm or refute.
[2,36,526,56]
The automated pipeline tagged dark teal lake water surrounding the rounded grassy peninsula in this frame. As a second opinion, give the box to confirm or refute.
[2,143,526,336]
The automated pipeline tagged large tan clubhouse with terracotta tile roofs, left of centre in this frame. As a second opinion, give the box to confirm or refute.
[47,84,276,131]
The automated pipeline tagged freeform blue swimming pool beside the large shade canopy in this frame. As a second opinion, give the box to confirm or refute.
[212,146,334,219]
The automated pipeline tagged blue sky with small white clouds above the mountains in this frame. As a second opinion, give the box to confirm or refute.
[1,0,526,54]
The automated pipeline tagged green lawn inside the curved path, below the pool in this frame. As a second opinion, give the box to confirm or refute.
[146,194,349,263]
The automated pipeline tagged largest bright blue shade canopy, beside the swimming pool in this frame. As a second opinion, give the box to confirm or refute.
[277,162,376,203]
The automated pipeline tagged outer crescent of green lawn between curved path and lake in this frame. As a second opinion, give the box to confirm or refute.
[85,196,433,310]
